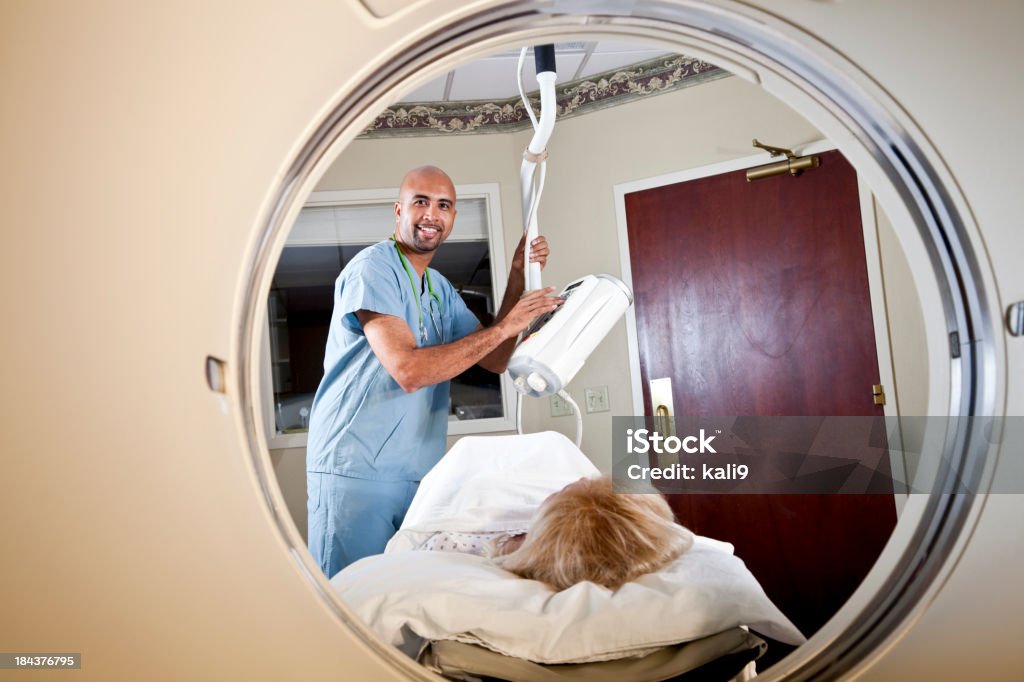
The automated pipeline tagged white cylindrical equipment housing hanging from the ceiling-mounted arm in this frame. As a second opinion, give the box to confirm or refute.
[508,274,633,397]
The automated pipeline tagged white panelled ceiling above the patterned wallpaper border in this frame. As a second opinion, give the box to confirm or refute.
[401,41,671,102]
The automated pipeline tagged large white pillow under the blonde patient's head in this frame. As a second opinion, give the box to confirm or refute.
[331,537,805,664]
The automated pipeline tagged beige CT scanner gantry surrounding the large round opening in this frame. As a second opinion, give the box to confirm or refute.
[0,0,1024,681]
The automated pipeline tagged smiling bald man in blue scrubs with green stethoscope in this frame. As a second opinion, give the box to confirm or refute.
[306,166,561,578]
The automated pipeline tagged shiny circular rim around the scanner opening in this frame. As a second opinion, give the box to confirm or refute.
[231,1,1004,680]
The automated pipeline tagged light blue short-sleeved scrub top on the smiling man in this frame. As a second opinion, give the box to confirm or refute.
[306,241,479,481]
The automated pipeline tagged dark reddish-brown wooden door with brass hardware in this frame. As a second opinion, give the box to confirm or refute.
[626,152,896,650]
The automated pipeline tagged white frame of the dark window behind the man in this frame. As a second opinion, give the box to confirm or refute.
[261,182,515,450]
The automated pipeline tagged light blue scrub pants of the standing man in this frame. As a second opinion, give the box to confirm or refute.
[306,472,420,578]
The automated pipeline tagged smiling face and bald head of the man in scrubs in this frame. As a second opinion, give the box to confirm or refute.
[394,166,455,254]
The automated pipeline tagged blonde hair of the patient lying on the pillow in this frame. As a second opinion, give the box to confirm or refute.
[493,476,693,591]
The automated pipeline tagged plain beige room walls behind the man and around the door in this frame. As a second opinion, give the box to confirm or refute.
[274,78,927,532]
